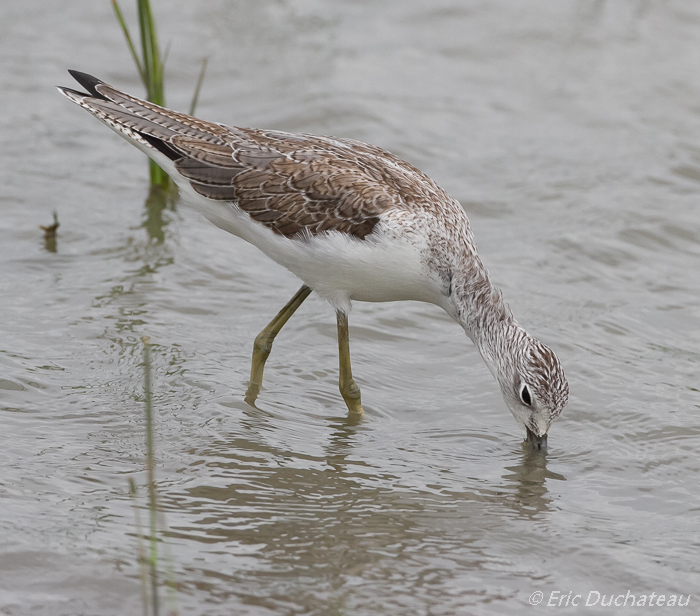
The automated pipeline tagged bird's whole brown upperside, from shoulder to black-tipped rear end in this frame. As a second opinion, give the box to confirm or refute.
[60,71,432,239]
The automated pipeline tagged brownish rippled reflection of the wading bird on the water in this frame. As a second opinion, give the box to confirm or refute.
[154,418,563,614]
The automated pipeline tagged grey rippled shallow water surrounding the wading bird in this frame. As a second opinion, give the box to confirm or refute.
[0,0,700,616]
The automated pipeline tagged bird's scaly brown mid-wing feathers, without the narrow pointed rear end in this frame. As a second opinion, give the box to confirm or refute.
[170,128,422,239]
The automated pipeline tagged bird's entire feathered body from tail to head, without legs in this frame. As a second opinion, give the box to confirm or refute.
[60,71,568,442]
